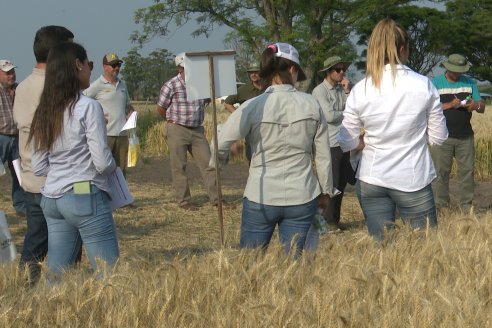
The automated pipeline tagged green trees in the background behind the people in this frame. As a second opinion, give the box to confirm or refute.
[122,0,492,99]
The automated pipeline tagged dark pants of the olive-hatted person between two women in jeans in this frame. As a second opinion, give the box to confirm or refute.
[324,147,352,224]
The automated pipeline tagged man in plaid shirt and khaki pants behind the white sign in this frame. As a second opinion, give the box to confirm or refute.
[157,53,217,210]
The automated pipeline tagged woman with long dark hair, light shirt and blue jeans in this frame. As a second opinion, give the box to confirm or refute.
[28,42,119,273]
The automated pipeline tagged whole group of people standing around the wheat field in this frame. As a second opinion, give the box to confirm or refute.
[0,19,485,281]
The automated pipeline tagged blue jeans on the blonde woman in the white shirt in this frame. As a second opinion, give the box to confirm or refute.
[356,180,437,240]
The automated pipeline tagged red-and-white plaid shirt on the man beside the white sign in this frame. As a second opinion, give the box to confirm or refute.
[157,74,205,127]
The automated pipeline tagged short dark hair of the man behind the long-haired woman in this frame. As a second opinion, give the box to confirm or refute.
[33,25,74,63]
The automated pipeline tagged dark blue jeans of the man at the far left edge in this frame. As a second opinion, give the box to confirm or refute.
[0,134,26,212]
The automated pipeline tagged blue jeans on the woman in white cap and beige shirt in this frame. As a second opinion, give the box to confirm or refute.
[239,198,317,255]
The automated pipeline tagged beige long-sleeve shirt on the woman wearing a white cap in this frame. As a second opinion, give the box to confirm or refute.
[211,85,338,206]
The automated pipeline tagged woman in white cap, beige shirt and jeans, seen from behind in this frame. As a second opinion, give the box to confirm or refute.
[211,43,334,254]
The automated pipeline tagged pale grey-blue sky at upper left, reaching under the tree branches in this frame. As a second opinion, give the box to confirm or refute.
[0,0,228,82]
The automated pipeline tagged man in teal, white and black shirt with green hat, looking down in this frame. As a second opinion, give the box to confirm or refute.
[430,54,485,211]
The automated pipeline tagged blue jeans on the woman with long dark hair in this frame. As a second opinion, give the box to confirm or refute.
[41,186,119,274]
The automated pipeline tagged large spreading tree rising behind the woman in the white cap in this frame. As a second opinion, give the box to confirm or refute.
[131,0,409,90]
